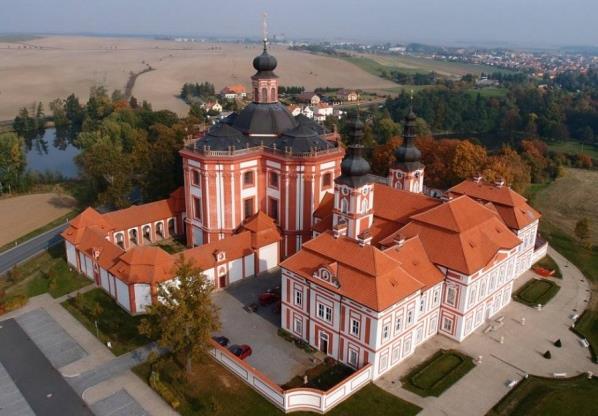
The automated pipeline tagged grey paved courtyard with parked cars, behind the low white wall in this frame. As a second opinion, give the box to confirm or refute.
[214,269,318,384]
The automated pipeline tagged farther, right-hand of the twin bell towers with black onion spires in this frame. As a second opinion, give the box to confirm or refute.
[388,110,424,193]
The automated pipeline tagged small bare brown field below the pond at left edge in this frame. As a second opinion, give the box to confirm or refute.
[0,193,75,246]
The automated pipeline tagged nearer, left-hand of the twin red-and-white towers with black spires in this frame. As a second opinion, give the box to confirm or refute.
[332,114,374,243]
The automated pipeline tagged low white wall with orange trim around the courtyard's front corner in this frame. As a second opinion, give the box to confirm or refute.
[210,342,374,413]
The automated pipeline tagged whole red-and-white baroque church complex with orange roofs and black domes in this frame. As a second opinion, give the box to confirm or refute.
[62,41,547,378]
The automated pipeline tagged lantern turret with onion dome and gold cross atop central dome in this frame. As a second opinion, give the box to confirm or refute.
[251,13,278,104]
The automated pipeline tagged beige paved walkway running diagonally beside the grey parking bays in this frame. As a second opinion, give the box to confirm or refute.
[0,286,177,416]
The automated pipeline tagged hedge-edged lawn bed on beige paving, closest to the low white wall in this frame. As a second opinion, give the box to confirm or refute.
[401,350,475,397]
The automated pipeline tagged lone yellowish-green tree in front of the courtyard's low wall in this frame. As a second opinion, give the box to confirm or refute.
[139,255,220,373]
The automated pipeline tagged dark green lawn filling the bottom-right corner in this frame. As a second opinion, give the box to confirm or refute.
[487,375,598,416]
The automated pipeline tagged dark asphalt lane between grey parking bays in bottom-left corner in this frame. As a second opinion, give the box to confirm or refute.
[0,319,93,416]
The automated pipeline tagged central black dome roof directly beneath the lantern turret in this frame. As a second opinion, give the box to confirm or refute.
[233,102,297,136]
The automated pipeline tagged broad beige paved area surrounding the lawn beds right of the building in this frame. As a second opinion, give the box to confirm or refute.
[376,249,598,416]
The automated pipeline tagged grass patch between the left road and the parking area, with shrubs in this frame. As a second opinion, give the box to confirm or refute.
[0,244,92,298]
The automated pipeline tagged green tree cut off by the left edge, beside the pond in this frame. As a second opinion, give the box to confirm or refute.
[0,133,27,193]
